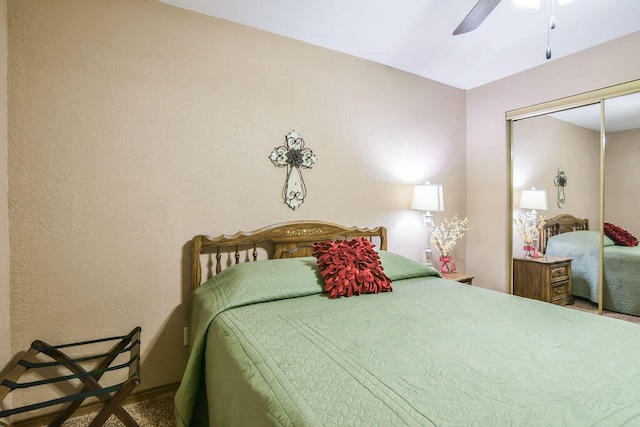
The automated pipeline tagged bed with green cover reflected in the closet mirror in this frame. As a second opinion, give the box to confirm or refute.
[542,214,640,316]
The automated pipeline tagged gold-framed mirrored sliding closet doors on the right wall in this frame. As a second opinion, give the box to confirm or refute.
[507,81,640,315]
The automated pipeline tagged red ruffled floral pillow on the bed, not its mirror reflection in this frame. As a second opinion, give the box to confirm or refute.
[313,238,393,298]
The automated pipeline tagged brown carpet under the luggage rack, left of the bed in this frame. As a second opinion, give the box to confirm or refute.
[62,393,176,427]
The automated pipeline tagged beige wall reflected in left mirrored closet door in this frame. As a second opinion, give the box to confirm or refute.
[513,116,600,256]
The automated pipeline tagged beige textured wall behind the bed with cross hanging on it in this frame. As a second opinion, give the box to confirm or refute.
[8,0,464,404]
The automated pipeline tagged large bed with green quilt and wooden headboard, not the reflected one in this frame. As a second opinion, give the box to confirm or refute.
[175,222,640,426]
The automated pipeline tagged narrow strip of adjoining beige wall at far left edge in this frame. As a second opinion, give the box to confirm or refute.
[0,1,12,406]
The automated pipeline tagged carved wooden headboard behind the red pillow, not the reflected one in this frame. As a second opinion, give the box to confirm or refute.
[191,221,387,289]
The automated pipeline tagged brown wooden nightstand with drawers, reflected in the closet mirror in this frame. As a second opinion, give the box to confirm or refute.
[513,255,573,305]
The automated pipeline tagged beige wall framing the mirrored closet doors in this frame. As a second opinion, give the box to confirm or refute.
[466,32,640,291]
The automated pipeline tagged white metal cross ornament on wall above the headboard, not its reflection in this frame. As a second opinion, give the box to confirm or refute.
[269,130,318,210]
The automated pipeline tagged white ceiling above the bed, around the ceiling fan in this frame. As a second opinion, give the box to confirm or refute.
[159,0,640,89]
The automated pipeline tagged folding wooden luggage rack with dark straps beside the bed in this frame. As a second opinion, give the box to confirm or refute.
[0,326,141,427]
